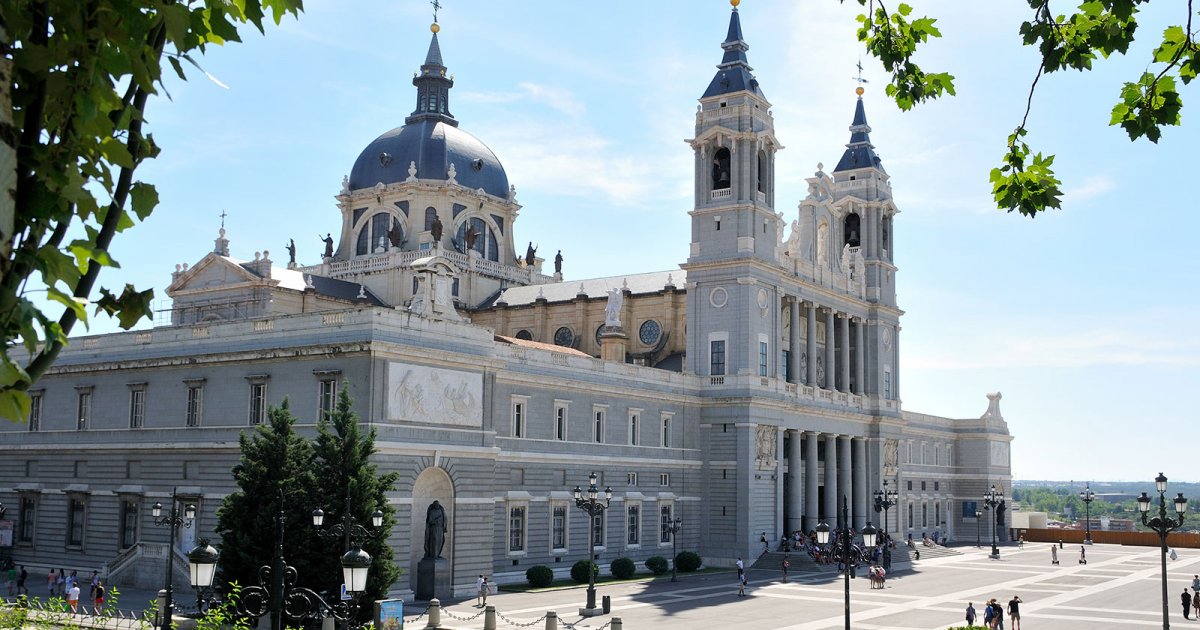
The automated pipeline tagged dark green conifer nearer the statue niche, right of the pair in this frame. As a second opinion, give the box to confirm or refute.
[313,383,401,612]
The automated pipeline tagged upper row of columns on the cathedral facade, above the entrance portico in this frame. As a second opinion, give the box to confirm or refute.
[787,298,866,395]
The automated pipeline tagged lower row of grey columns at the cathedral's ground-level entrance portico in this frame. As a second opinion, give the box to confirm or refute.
[784,430,870,532]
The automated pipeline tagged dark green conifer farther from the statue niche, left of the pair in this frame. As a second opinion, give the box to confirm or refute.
[216,400,317,592]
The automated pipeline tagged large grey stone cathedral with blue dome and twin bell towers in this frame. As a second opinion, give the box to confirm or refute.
[0,1,1012,598]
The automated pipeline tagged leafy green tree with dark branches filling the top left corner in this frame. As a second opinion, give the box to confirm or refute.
[0,0,302,420]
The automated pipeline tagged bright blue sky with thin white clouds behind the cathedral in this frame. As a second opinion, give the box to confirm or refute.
[77,0,1200,487]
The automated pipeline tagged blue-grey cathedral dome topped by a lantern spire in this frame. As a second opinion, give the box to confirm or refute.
[349,30,509,198]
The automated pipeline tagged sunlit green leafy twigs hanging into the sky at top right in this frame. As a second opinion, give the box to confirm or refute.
[839,0,1200,217]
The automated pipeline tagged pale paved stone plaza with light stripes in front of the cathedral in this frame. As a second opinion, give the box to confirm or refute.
[429,544,1200,630]
